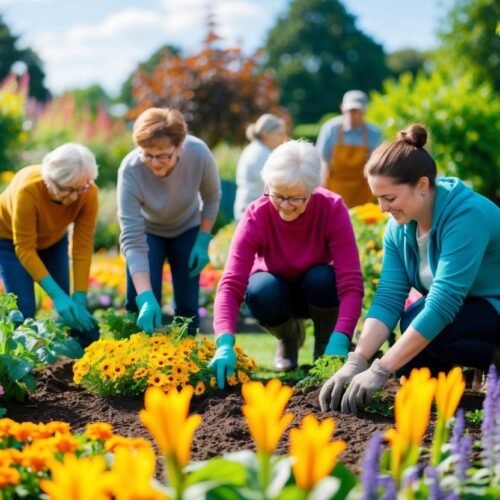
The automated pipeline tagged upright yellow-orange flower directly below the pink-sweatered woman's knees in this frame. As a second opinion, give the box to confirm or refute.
[242,379,293,454]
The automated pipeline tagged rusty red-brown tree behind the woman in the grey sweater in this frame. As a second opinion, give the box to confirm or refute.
[130,13,282,147]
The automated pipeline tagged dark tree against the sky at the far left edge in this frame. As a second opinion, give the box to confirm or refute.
[0,15,50,101]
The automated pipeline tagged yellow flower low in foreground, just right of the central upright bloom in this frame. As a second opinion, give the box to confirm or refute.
[290,414,345,491]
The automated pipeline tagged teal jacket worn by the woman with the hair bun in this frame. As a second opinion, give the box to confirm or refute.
[367,177,500,340]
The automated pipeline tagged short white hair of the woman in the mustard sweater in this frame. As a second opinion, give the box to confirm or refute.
[42,142,98,186]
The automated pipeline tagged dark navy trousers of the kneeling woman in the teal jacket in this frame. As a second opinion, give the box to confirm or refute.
[396,297,500,376]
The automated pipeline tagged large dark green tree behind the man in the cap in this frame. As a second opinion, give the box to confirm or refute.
[265,0,389,123]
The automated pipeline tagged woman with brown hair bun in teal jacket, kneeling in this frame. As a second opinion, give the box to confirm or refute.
[319,125,500,413]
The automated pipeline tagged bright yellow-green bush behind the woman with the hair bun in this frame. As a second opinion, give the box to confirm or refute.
[367,72,500,202]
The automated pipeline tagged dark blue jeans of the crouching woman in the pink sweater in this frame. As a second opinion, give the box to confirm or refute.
[245,264,339,326]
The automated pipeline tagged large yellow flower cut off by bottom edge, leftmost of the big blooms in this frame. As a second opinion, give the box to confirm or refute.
[40,455,108,500]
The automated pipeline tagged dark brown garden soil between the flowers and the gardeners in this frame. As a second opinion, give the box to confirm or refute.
[1,360,483,472]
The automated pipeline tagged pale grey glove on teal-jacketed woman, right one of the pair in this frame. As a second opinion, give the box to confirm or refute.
[341,359,391,415]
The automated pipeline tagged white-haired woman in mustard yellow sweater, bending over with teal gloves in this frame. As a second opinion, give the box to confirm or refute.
[0,143,99,347]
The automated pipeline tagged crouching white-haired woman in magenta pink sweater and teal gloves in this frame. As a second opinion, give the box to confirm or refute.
[210,141,363,388]
